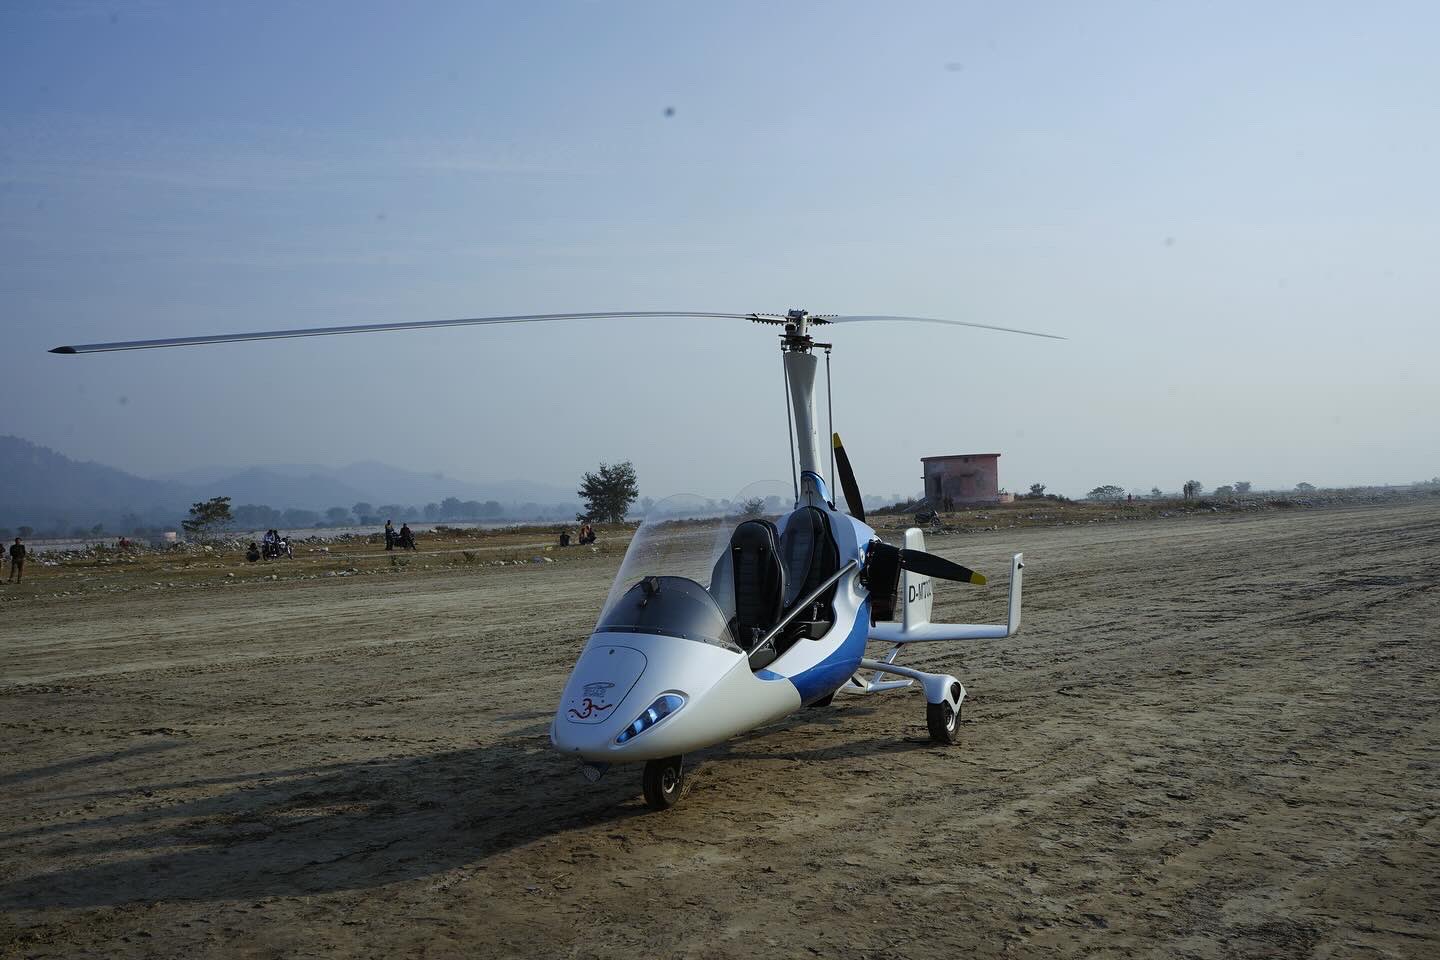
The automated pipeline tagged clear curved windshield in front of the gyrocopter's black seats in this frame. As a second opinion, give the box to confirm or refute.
[595,481,795,651]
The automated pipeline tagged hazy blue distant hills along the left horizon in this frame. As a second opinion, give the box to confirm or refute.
[0,436,576,531]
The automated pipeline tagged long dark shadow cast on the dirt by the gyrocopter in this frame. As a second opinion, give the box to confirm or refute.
[0,707,926,910]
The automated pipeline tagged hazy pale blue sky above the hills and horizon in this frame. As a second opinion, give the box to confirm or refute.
[0,0,1440,498]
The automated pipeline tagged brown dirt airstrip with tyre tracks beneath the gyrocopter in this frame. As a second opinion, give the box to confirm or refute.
[0,501,1440,959]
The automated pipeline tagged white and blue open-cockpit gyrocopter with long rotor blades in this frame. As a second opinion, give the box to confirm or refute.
[50,309,1063,809]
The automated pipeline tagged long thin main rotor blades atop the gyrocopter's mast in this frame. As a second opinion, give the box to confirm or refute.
[50,309,1064,355]
